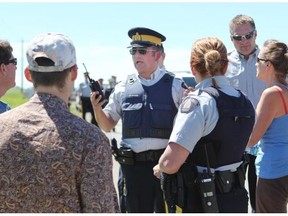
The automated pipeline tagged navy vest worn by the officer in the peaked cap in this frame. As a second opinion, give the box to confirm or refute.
[122,73,177,139]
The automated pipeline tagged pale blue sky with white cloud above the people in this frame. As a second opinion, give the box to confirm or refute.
[0,2,288,88]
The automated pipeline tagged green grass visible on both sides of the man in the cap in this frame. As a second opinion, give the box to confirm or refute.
[1,87,82,117]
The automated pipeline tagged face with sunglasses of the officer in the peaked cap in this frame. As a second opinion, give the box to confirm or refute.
[130,47,160,79]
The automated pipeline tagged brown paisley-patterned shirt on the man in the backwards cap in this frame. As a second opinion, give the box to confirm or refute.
[0,93,119,213]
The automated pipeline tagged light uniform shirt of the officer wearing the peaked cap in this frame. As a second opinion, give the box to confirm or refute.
[104,68,184,153]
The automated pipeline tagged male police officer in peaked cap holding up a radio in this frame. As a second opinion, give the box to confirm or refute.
[90,27,184,213]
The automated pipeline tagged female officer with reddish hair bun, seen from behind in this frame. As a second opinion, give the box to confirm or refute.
[154,38,255,212]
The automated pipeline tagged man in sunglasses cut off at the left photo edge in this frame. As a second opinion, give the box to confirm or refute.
[0,40,17,113]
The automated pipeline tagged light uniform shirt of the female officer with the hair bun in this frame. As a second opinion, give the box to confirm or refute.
[169,76,240,153]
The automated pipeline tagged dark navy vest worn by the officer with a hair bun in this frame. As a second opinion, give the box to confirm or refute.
[190,87,255,168]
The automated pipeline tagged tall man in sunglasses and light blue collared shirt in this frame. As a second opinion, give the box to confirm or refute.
[226,14,266,212]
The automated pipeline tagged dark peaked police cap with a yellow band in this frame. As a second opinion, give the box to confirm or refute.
[128,27,166,47]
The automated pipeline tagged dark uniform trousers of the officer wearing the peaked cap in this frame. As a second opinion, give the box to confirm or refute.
[121,161,165,213]
